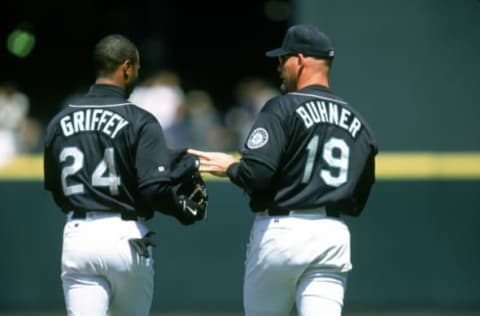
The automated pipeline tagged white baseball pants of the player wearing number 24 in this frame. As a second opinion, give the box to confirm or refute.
[61,213,154,316]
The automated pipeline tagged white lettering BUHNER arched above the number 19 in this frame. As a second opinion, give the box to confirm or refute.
[296,100,362,139]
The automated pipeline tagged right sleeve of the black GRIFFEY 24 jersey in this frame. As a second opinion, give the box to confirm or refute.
[135,120,172,187]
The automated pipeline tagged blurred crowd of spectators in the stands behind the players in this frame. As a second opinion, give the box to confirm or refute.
[0,70,280,167]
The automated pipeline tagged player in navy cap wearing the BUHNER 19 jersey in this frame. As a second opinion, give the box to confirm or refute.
[189,24,377,316]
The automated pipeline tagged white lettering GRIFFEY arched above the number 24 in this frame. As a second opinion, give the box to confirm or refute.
[60,109,128,139]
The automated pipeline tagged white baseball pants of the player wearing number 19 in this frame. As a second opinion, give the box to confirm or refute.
[243,212,352,316]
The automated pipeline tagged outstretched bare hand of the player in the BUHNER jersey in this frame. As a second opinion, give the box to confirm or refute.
[188,149,239,177]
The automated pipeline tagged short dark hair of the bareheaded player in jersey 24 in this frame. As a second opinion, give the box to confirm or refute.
[93,34,138,76]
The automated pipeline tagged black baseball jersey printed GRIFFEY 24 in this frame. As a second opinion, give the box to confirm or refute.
[44,85,172,217]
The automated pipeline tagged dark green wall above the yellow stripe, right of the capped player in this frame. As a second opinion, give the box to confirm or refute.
[291,0,480,151]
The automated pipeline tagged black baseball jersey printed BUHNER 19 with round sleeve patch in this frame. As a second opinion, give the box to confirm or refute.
[227,85,377,215]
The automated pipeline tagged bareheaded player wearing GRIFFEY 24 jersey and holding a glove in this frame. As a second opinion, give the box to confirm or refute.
[44,34,206,316]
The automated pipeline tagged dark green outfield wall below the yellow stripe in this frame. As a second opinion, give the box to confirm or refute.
[0,179,480,311]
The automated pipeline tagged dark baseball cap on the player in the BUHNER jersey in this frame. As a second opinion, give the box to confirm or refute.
[265,24,335,59]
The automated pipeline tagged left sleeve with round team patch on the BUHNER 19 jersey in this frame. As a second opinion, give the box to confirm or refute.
[242,102,287,170]
